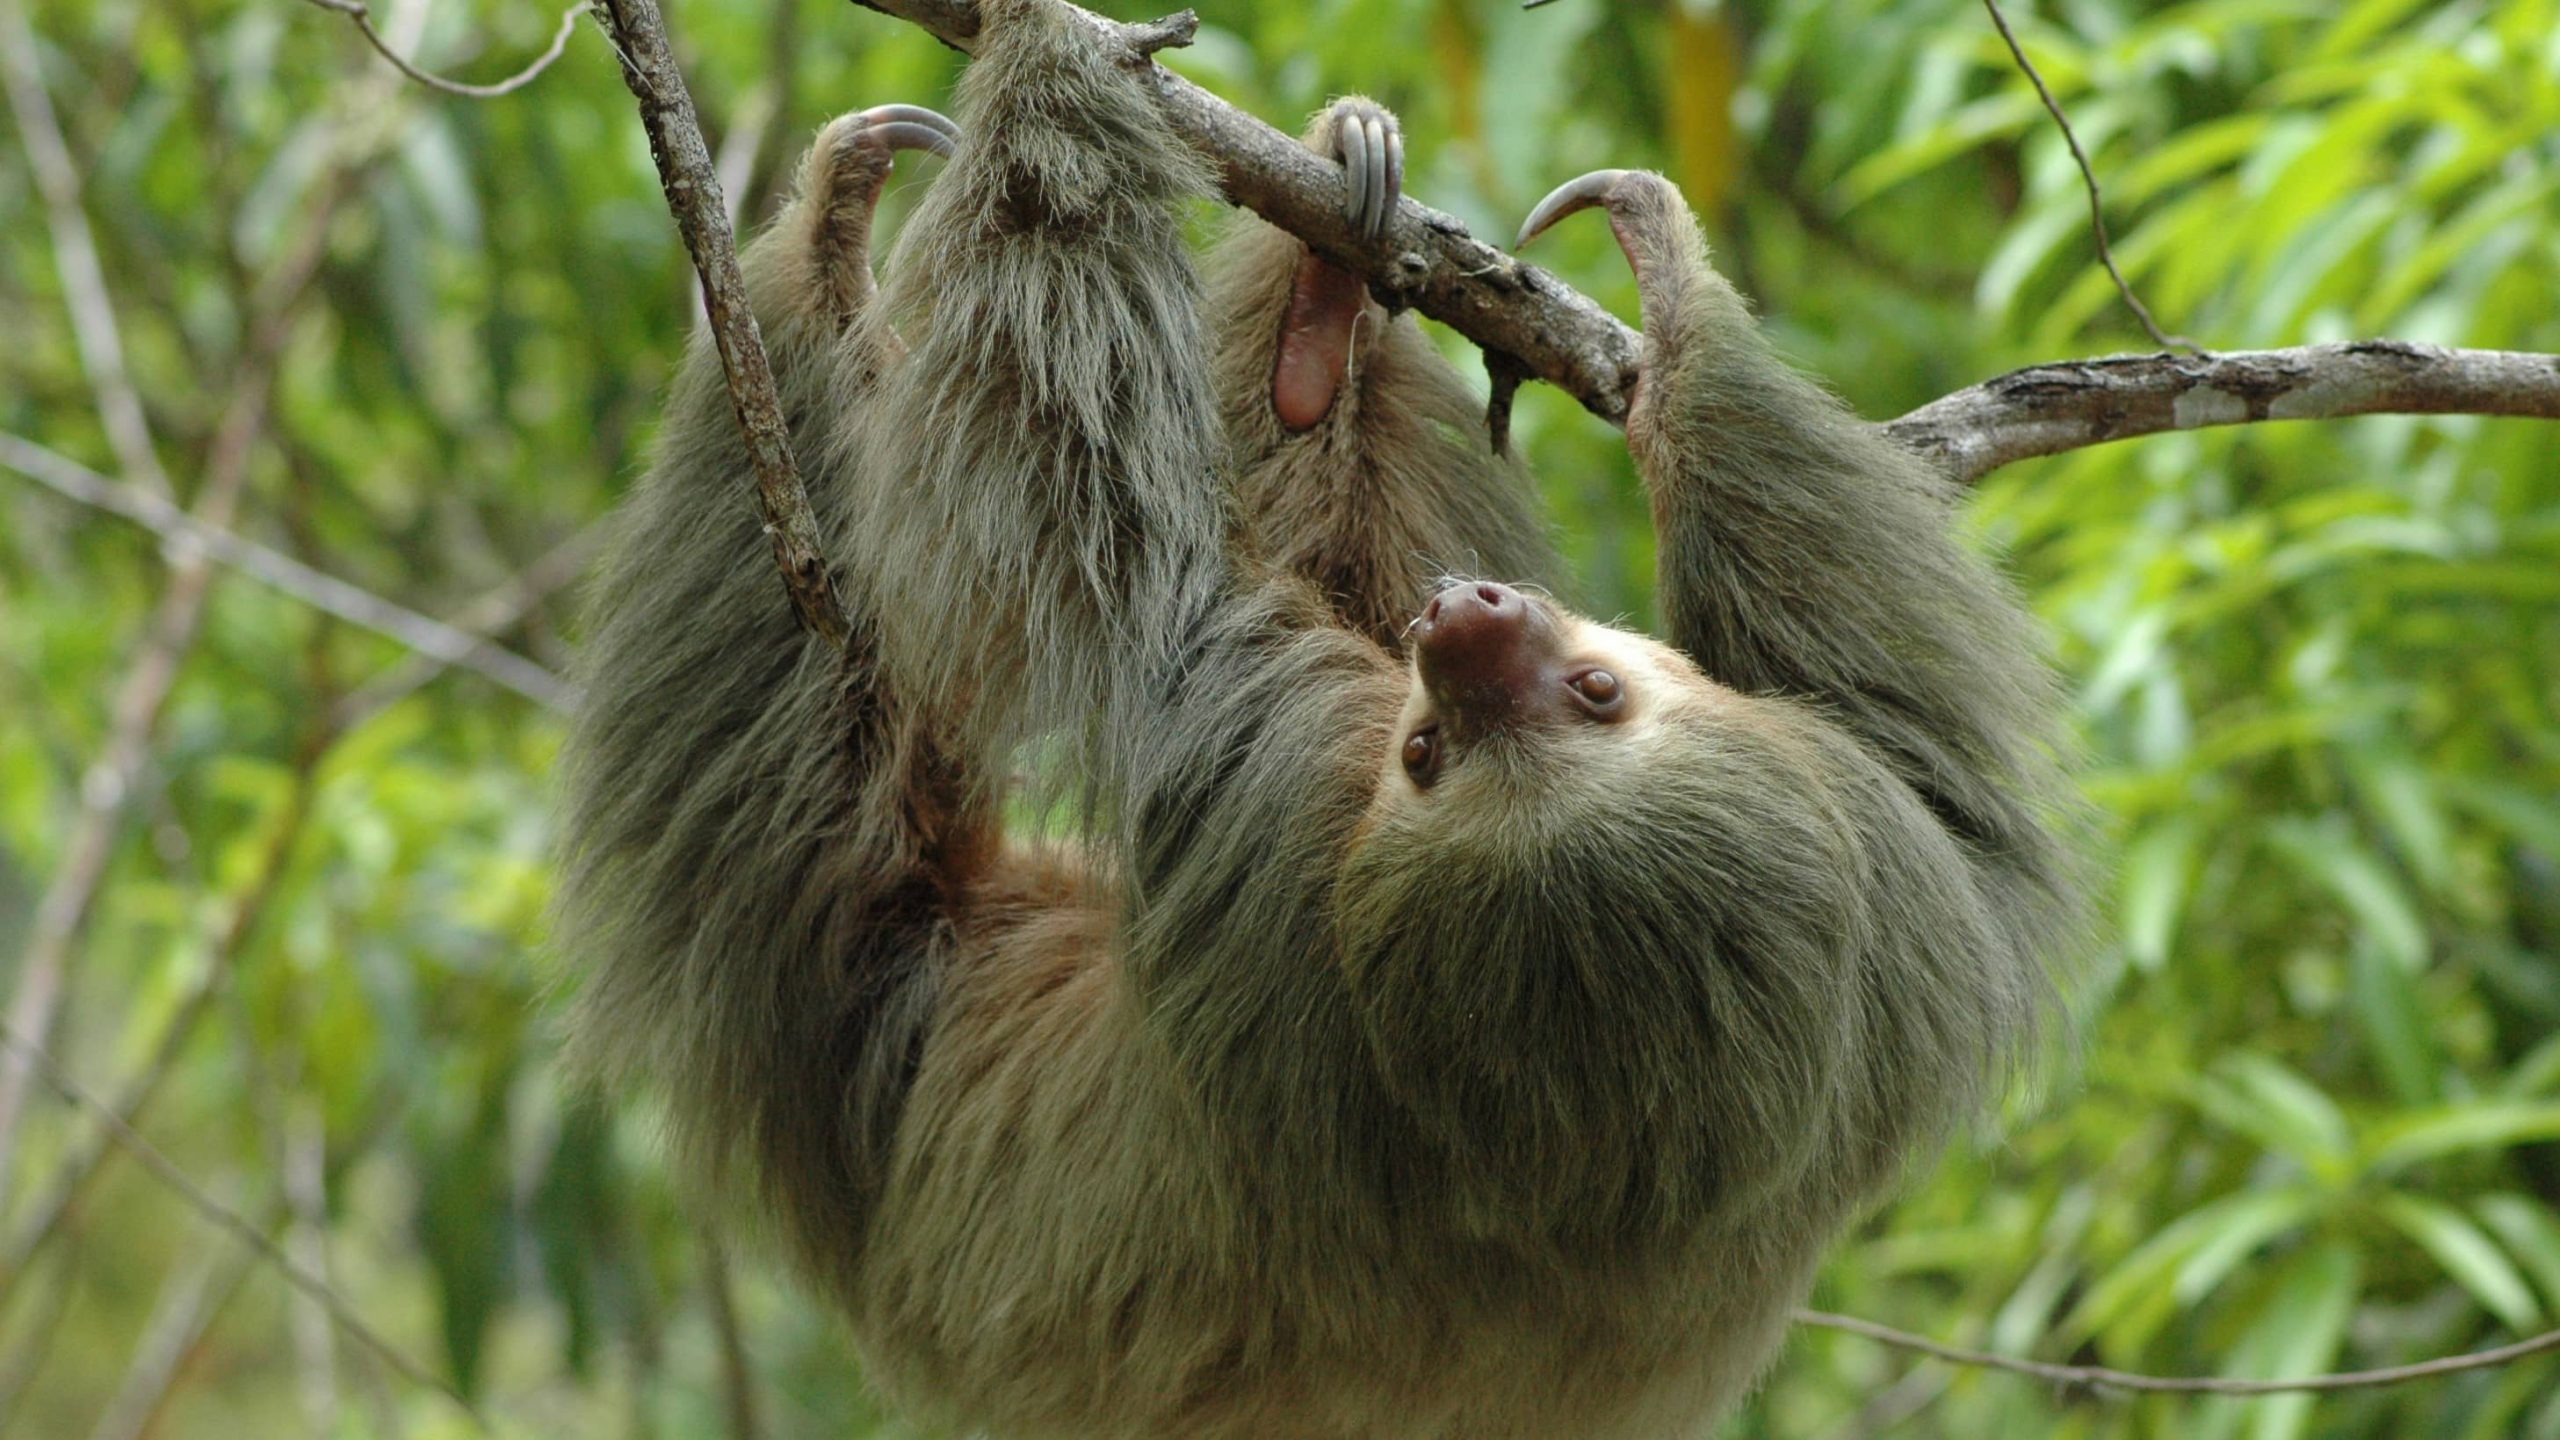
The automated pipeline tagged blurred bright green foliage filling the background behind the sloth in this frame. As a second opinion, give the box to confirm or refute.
[0,0,2560,1440]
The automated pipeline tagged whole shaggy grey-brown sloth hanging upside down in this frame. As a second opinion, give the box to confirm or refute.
[558,0,2076,1440]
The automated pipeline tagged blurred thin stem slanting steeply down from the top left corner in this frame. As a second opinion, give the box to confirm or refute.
[0,0,169,497]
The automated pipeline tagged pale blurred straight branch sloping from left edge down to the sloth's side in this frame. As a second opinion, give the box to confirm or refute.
[0,433,576,710]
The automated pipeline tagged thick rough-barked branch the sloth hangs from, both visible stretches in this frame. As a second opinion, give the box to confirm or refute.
[855,0,2560,482]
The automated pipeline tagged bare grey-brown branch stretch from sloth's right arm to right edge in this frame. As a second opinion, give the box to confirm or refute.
[1884,341,2560,482]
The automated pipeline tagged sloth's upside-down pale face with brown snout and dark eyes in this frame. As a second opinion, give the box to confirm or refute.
[1372,582,1715,828]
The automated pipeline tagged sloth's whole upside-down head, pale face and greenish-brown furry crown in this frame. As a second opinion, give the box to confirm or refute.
[1336,582,1859,1207]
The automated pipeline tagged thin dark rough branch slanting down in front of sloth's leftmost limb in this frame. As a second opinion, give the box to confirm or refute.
[594,0,852,648]
